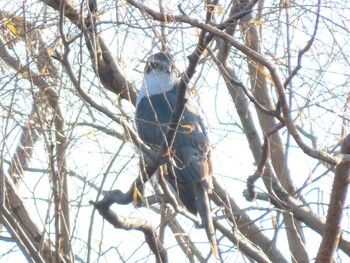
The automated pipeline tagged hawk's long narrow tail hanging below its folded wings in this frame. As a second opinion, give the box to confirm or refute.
[195,183,219,259]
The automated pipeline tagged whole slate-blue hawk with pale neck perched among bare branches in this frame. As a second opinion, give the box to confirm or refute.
[135,52,218,257]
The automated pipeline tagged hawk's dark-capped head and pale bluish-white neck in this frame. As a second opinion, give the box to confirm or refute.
[136,52,177,105]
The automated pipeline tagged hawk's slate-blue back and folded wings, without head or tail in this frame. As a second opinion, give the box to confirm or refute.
[136,86,212,188]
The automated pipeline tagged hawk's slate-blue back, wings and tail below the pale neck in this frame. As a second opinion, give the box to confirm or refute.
[136,88,218,257]
